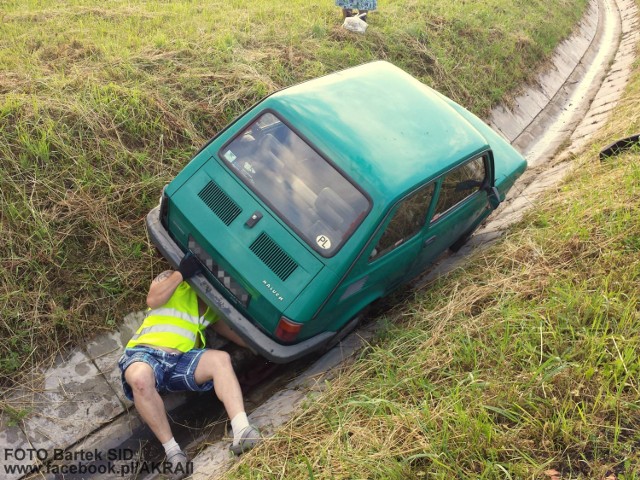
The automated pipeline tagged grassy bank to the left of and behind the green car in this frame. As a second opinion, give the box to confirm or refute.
[0,0,586,384]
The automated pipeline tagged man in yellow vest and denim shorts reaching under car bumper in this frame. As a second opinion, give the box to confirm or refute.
[119,254,260,479]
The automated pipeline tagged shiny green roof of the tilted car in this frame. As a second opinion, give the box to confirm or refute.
[263,61,488,203]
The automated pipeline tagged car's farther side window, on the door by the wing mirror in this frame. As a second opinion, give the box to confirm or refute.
[431,157,487,222]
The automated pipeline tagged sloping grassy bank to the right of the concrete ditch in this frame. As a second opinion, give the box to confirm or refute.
[229,39,640,480]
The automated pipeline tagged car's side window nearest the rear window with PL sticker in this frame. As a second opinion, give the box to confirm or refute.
[371,184,434,258]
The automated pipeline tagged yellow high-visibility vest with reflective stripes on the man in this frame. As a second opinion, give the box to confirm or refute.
[126,282,218,352]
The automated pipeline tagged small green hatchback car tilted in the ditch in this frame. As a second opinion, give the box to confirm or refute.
[147,61,526,363]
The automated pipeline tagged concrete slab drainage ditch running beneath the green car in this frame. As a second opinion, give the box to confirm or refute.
[0,0,639,480]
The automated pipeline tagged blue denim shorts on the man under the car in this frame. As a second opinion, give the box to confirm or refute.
[118,345,213,400]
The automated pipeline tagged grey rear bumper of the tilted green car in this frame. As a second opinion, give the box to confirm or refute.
[147,206,336,363]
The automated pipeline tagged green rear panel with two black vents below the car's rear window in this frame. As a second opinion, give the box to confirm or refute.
[168,158,323,333]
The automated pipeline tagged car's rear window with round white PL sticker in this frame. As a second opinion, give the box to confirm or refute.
[220,113,369,257]
